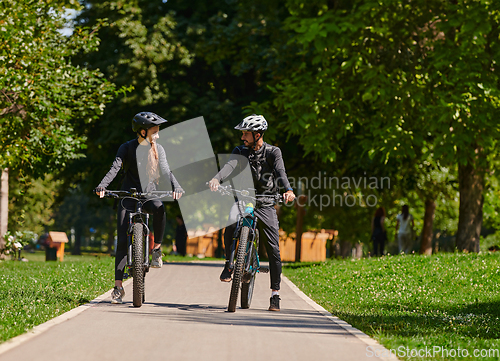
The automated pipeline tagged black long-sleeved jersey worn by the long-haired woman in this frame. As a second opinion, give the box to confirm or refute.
[98,139,181,192]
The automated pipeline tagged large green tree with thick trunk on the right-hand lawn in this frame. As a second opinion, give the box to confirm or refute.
[264,0,500,251]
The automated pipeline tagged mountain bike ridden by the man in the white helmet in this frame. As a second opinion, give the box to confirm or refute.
[213,185,283,312]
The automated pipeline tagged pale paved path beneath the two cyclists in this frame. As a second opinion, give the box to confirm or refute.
[0,262,398,361]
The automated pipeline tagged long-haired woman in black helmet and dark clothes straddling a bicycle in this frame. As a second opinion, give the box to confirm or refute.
[95,112,183,303]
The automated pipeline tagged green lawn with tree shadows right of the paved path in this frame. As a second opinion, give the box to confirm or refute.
[284,252,500,360]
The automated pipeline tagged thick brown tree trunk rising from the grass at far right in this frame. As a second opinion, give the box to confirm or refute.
[457,164,484,252]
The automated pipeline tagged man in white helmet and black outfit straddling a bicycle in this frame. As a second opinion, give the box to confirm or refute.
[209,114,295,311]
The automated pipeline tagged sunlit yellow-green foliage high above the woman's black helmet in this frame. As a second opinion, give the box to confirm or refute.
[80,0,194,107]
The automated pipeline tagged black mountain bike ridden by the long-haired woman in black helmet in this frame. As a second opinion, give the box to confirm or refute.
[100,188,173,307]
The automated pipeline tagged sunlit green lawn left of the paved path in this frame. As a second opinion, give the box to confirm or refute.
[0,252,114,343]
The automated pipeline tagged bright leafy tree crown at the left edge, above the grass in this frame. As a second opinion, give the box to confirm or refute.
[0,0,116,249]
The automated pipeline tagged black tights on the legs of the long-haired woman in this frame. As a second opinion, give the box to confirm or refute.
[115,199,167,281]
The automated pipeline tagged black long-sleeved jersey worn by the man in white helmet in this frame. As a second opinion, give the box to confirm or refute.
[214,142,292,206]
